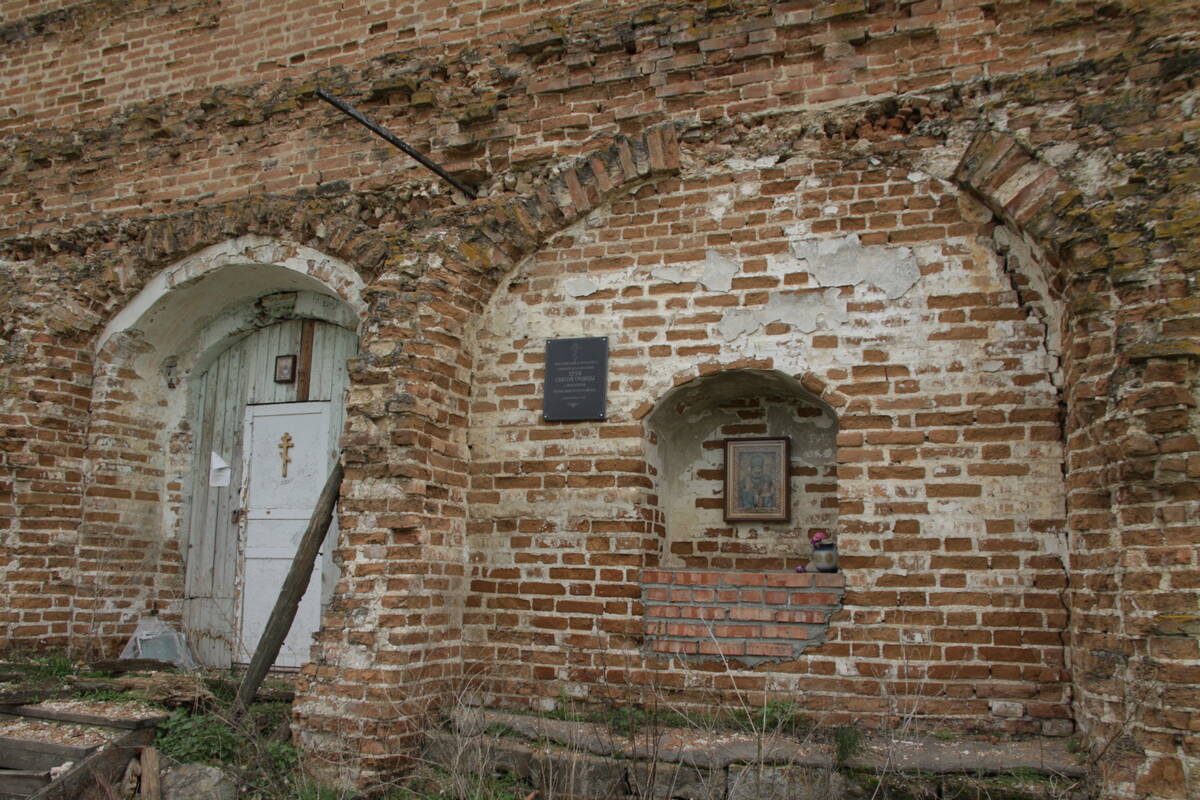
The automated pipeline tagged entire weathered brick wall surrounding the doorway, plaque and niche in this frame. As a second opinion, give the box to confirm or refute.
[0,0,1200,798]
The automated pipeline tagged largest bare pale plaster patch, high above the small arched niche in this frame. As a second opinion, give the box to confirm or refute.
[792,234,920,300]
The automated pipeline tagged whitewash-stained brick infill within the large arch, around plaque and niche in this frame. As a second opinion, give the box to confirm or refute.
[464,137,1069,733]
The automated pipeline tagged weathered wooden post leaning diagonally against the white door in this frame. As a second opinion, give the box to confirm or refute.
[234,461,344,716]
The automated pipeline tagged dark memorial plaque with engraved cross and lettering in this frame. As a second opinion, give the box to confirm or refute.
[541,336,608,422]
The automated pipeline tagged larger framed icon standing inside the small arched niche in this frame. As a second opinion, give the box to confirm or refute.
[725,437,792,522]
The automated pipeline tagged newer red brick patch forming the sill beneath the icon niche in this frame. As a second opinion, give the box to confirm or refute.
[642,570,846,664]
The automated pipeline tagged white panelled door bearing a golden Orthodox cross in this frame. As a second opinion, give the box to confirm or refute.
[236,402,337,667]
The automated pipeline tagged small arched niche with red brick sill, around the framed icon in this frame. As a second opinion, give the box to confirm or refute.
[642,360,847,668]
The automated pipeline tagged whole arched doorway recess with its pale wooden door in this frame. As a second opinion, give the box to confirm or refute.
[87,236,364,666]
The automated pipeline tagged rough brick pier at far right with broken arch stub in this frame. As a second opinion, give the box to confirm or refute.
[955,131,1200,795]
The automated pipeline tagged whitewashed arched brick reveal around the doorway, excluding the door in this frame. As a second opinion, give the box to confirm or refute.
[72,235,365,650]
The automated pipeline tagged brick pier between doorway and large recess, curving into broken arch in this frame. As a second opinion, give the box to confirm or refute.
[296,125,679,786]
